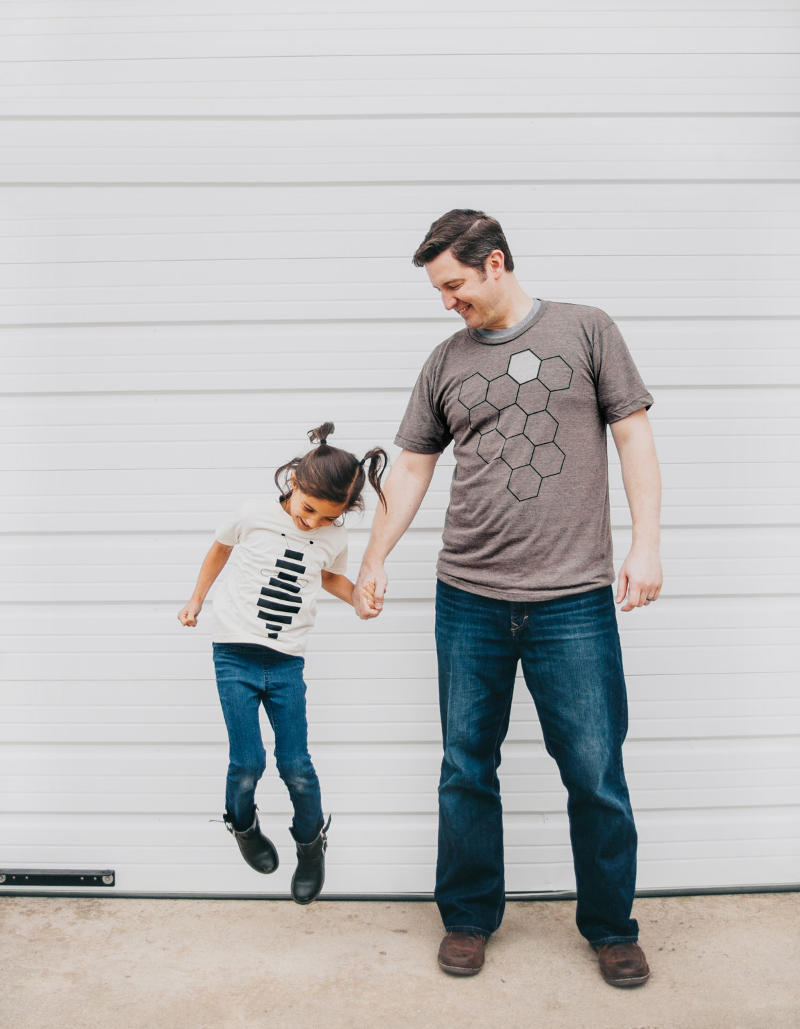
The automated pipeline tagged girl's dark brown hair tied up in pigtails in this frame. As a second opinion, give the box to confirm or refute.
[275,422,389,511]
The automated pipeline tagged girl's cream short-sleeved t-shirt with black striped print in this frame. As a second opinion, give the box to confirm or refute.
[212,497,347,654]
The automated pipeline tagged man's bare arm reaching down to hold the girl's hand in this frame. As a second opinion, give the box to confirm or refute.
[353,450,440,618]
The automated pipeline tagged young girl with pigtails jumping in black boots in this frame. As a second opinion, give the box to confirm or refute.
[178,422,387,903]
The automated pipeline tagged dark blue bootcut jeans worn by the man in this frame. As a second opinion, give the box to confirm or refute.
[436,581,638,946]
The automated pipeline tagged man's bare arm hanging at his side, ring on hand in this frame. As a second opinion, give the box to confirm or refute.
[611,409,662,611]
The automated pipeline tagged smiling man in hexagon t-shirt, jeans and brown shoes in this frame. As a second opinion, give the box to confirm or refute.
[356,210,661,986]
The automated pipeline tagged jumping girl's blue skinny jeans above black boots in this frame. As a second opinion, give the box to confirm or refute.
[213,643,322,843]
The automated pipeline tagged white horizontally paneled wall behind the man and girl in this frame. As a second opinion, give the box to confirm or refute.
[0,0,800,893]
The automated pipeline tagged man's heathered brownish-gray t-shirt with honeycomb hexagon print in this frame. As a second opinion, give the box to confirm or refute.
[395,300,653,601]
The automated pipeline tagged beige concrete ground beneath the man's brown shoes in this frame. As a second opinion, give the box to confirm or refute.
[0,893,800,1029]
